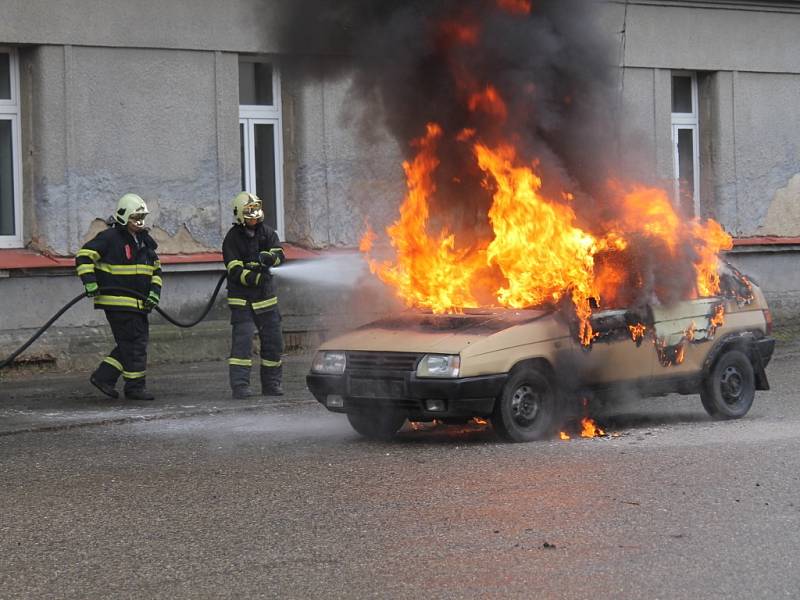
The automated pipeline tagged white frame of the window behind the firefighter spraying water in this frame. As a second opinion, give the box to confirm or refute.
[239,56,286,240]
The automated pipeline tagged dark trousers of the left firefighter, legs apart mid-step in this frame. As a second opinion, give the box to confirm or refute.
[94,310,150,393]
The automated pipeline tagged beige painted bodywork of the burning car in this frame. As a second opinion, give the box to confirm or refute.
[320,285,767,384]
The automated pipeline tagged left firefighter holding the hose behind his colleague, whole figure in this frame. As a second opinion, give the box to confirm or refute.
[75,194,161,400]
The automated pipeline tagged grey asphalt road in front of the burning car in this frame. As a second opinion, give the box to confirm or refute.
[0,356,800,599]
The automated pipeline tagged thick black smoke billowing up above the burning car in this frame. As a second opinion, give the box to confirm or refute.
[279,0,615,229]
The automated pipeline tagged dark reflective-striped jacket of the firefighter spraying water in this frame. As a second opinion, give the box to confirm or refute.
[222,223,285,314]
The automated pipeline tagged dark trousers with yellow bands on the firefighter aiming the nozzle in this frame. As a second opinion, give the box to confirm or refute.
[228,306,283,392]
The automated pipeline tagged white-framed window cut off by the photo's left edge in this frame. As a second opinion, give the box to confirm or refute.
[0,47,22,248]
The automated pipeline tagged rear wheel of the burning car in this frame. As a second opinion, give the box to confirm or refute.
[700,350,756,419]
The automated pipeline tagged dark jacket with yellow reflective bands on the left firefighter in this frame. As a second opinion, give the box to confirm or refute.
[75,225,161,313]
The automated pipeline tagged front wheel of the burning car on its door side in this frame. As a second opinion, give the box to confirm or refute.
[492,367,556,442]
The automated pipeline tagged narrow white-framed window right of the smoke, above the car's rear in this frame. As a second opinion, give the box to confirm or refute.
[672,71,700,216]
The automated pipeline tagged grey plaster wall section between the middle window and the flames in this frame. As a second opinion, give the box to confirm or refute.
[283,67,406,248]
